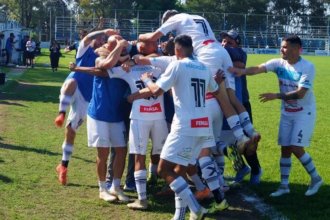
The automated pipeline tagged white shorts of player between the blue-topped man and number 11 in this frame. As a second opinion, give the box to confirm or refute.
[129,119,168,155]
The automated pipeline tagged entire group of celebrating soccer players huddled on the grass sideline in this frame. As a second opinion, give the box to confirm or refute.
[55,10,322,219]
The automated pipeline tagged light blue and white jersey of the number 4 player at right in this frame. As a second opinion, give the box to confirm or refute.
[263,58,316,115]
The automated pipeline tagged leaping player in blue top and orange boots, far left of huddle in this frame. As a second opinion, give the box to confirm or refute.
[55,29,117,185]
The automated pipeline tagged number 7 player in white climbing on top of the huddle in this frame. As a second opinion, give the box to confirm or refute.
[139,10,260,155]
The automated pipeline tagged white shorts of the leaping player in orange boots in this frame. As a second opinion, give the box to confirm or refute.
[66,87,89,131]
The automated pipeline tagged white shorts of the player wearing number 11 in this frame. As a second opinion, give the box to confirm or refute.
[160,132,215,166]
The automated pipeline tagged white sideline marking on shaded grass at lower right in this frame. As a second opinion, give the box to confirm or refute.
[240,193,288,220]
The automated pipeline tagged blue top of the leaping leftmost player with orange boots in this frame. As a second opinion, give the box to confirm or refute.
[67,46,97,102]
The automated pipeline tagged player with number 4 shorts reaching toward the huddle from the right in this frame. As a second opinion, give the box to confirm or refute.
[230,36,323,197]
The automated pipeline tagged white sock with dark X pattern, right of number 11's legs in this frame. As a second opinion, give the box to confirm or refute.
[198,156,220,191]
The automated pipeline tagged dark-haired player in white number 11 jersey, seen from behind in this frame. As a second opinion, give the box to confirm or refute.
[136,35,227,219]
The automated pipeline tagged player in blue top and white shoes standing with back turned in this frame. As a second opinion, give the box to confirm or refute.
[69,35,129,202]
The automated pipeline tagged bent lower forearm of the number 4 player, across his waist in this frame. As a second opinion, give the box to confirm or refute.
[259,87,308,102]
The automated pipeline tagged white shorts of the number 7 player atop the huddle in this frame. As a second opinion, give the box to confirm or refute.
[197,42,235,90]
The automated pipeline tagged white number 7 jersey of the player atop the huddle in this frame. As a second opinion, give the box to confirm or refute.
[157,13,217,55]
